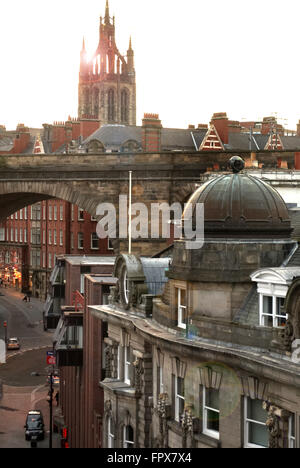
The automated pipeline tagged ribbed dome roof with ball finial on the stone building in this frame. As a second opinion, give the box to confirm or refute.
[183,157,292,239]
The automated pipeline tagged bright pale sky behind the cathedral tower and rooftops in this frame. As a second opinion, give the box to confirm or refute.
[0,0,300,130]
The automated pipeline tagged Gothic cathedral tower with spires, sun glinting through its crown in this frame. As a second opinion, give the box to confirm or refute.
[78,0,136,125]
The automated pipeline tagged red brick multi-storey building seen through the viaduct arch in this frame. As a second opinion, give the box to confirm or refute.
[0,200,112,299]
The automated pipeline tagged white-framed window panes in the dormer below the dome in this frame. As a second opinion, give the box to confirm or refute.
[259,294,287,328]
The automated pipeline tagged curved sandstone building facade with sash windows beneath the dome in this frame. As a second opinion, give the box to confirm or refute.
[89,168,300,449]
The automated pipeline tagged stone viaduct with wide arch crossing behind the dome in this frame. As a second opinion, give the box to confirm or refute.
[0,151,300,252]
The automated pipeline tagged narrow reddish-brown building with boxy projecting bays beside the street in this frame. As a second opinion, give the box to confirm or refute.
[51,255,116,448]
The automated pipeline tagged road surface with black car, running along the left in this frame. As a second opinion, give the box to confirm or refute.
[0,288,59,448]
